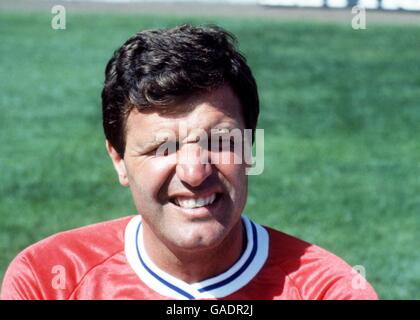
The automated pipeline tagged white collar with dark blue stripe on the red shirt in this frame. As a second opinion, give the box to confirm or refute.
[125,215,268,299]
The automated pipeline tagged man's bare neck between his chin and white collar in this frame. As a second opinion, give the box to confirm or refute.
[143,220,246,283]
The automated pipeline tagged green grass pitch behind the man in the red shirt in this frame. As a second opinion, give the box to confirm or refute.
[0,12,420,299]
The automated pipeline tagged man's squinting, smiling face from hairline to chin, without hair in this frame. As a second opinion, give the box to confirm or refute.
[108,86,247,250]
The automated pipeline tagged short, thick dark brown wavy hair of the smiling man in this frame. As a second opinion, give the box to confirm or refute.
[102,25,259,157]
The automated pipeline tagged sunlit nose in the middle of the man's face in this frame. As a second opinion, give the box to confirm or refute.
[176,143,212,187]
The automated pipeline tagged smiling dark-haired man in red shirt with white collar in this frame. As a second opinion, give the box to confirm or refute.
[1,25,377,299]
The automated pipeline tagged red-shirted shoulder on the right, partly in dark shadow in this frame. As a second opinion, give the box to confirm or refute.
[266,227,378,300]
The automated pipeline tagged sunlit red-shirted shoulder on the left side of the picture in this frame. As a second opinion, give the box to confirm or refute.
[0,217,131,299]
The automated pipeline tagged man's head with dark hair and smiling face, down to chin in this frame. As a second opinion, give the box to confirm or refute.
[102,26,259,258]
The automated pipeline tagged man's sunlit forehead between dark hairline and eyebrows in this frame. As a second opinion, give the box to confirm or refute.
[126,85,244,139]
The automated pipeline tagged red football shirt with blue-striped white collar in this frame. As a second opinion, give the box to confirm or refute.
[0,216,378,300]
